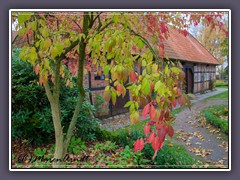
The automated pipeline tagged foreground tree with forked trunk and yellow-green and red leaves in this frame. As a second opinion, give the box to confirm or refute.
[13,12,227,167]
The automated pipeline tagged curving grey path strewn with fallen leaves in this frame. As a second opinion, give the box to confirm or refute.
[174,99,228,166]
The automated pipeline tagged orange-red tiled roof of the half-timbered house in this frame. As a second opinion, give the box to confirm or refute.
[164,26,220,65]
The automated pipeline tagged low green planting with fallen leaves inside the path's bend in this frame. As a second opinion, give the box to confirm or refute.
[202,105,228,134]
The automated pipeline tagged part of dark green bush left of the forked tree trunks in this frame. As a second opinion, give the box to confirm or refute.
[12,49,53,144]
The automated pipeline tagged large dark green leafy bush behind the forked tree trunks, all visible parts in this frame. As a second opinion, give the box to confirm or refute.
[12,49,100,145]
